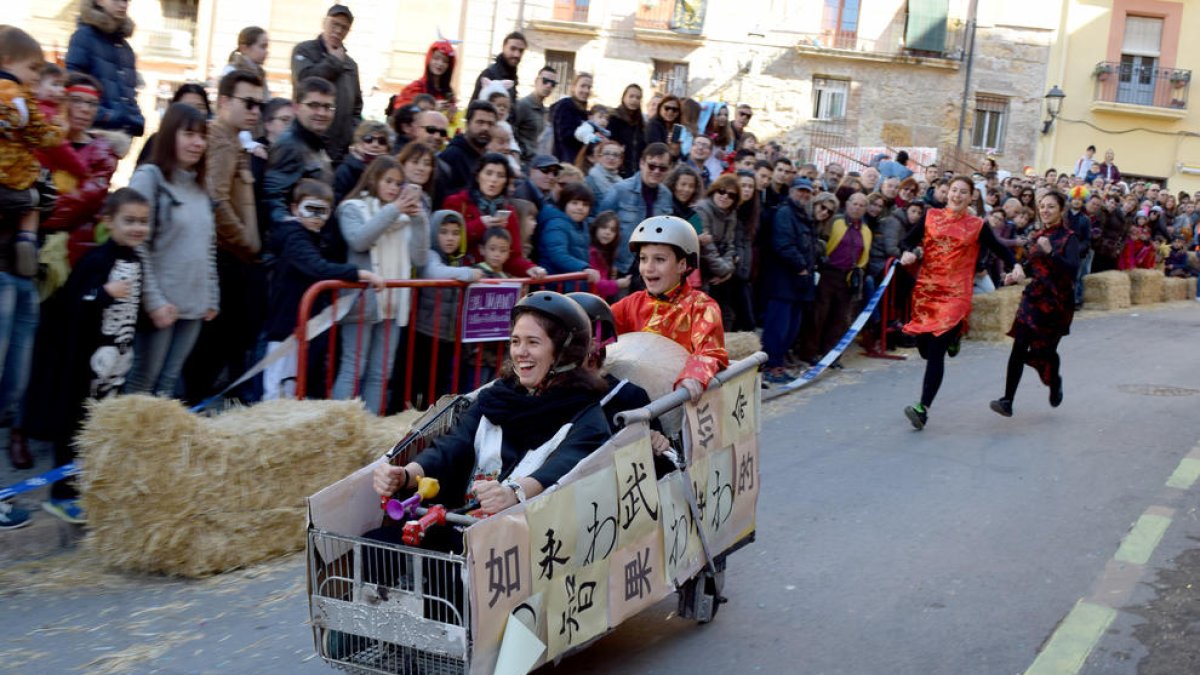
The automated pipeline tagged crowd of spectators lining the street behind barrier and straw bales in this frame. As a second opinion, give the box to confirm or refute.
[0,0,1200,526]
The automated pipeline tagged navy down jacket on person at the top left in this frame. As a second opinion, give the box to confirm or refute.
[66,0,145,136]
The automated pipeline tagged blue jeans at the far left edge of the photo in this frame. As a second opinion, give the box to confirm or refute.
[0,271,38,426]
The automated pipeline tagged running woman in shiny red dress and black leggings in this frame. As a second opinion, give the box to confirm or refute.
[900,175,1025,430]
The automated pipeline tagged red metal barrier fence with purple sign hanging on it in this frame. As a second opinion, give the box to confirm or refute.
[295,273,595,414]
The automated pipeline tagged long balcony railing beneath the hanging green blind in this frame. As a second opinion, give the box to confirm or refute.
[799,12,962,59]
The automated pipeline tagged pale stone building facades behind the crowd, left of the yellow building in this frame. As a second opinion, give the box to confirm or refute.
[9,0,1060,176]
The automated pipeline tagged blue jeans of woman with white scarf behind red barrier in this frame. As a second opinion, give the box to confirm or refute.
[334,321,404,414]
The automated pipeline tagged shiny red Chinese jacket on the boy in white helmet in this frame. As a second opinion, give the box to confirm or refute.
[612,283,730,387]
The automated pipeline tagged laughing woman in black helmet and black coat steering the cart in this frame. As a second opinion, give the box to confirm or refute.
[367,291,610,542]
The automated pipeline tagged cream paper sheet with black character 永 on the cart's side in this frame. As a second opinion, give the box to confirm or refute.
[526,483,580,593]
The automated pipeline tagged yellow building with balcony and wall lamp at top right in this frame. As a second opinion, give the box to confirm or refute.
[1037,0,1200,192]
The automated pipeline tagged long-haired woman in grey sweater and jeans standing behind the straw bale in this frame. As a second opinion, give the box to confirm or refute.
[126,103,221,396]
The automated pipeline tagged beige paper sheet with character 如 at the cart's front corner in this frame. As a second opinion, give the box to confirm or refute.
[464,513,533,671]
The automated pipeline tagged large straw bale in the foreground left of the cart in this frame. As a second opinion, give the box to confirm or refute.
[77,396,418,577]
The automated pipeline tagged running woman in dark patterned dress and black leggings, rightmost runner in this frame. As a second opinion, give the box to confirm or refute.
[991,192,1080,417]
